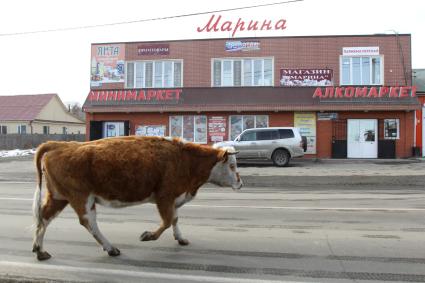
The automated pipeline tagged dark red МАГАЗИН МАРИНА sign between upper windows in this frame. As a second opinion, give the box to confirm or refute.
[280,69,333,86]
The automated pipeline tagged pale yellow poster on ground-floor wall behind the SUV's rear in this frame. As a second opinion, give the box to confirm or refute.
[294,112,316,154]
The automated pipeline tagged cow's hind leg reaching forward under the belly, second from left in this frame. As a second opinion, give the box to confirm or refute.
[71,195,121,256]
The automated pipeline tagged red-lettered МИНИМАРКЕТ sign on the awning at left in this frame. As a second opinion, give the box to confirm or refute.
[87,88,182,104]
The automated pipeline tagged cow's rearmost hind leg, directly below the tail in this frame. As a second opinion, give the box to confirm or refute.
[32,192,68,260]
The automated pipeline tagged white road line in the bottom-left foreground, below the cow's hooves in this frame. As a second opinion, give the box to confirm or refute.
[0,261,292,283]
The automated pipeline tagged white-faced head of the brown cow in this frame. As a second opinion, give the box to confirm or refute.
[208,147,242,190]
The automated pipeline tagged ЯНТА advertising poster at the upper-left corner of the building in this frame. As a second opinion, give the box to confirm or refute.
[90,44,125,87]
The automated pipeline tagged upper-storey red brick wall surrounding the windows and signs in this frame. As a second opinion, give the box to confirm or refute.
[93,35,412,89]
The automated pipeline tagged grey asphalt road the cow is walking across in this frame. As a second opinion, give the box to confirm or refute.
[0,161,425,283]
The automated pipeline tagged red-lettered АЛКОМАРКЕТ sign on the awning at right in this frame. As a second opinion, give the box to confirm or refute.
[313,86,416,99]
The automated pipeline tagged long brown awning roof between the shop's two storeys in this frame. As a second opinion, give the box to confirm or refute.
[83,87,420,112]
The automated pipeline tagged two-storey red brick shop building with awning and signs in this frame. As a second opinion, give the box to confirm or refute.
[84,34,420,158]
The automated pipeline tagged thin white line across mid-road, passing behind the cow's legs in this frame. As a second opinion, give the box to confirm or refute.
[0,197,425,211]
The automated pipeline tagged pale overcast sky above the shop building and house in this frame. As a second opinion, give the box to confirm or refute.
[0,0,425,104]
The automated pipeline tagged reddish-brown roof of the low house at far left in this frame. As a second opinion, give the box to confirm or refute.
[0,93,57,121]
